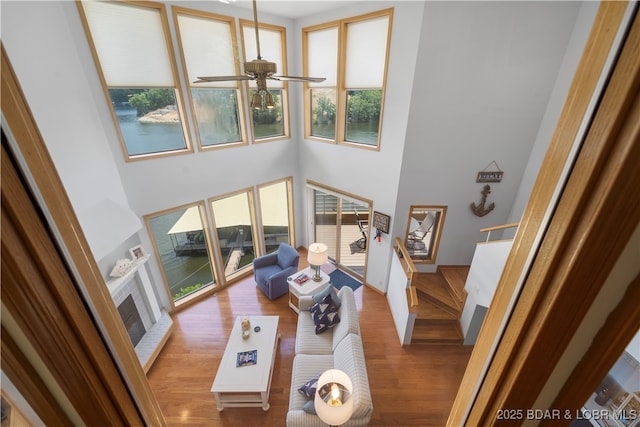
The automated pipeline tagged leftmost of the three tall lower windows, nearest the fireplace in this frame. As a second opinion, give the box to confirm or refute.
[145,203,215,303]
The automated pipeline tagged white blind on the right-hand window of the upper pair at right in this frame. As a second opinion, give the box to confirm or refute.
[345,16,389,88]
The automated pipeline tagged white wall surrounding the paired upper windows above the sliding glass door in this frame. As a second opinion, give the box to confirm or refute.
[296,1,424,292]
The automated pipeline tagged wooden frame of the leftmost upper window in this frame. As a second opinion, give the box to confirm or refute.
[76,1,193,162]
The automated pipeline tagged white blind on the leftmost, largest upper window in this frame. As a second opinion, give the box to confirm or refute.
[81,1,175,87]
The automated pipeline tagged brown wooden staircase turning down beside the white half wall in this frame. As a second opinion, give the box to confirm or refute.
[411,266,469,345]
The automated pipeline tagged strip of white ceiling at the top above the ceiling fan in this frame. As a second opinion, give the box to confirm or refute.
[219,0,364,20]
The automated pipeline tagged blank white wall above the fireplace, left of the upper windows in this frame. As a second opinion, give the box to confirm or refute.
[2,2,142,259]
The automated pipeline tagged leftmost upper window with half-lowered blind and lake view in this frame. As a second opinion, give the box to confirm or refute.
[77,1,191,160]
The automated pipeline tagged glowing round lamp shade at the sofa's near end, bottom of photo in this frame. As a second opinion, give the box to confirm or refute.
[314,369,353,426]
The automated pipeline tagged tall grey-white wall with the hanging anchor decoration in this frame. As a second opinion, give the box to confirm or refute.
[394,2,580,270]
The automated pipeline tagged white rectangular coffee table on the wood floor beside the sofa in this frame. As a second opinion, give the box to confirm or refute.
[211,316,280,411]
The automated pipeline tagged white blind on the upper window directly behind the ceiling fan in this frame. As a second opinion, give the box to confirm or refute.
[242,25,286,88]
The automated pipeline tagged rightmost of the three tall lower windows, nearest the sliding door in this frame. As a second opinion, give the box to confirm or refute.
[258,178,294,253]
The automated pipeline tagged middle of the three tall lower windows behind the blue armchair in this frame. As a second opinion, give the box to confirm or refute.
[210,189,256,278]
